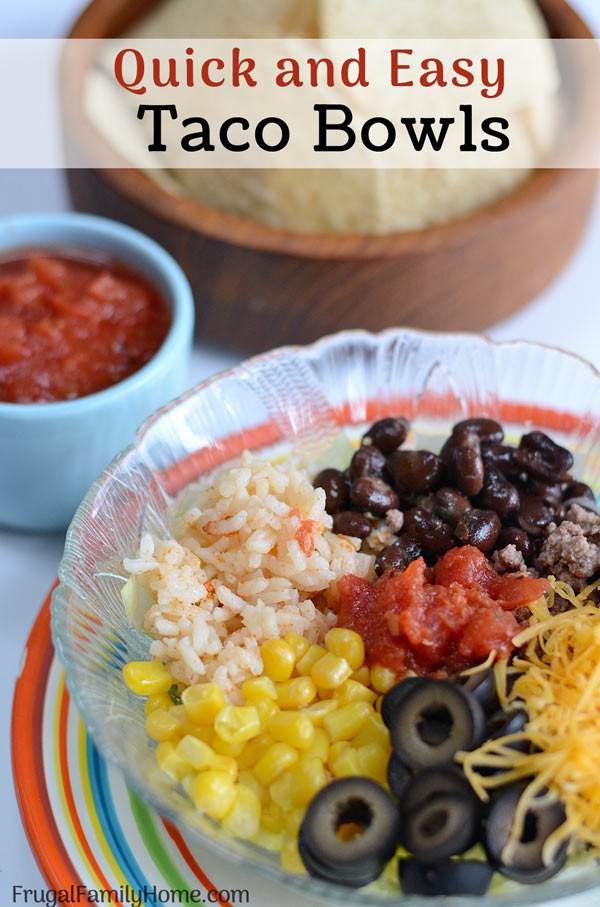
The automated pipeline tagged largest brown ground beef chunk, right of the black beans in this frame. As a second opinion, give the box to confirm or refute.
[537,505,600,589]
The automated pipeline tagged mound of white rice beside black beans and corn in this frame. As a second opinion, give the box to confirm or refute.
[124,453,374,699]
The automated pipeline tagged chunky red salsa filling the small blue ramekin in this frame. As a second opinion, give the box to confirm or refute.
[0,253,171,403]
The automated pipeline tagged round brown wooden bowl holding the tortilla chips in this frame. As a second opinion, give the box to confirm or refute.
[64,0,597,352]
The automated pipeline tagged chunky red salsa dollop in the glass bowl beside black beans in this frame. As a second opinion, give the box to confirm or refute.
[337,545,548,675]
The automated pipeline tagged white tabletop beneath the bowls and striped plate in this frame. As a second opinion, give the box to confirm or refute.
[0,0,600,907]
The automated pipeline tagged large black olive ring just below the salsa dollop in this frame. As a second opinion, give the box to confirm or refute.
[390,678,485,769]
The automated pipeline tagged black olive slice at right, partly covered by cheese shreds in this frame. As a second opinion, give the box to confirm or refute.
[483,782,567,884]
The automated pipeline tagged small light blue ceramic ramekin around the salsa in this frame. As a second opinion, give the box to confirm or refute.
[0,214,194,530]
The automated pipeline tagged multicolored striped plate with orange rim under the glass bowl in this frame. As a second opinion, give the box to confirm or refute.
[12,599,314,907]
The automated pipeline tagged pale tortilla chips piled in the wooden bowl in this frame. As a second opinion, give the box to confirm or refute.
[132,0,559,234]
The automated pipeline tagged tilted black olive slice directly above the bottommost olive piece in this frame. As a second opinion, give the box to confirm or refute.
[402,793,481,863]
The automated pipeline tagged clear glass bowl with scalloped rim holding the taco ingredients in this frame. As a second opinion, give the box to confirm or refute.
[52,329,600,907]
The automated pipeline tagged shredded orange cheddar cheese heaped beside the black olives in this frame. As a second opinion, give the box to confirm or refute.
[458,577,600,862]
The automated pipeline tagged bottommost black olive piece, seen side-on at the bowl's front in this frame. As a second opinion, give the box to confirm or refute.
[398,860,494,898]
